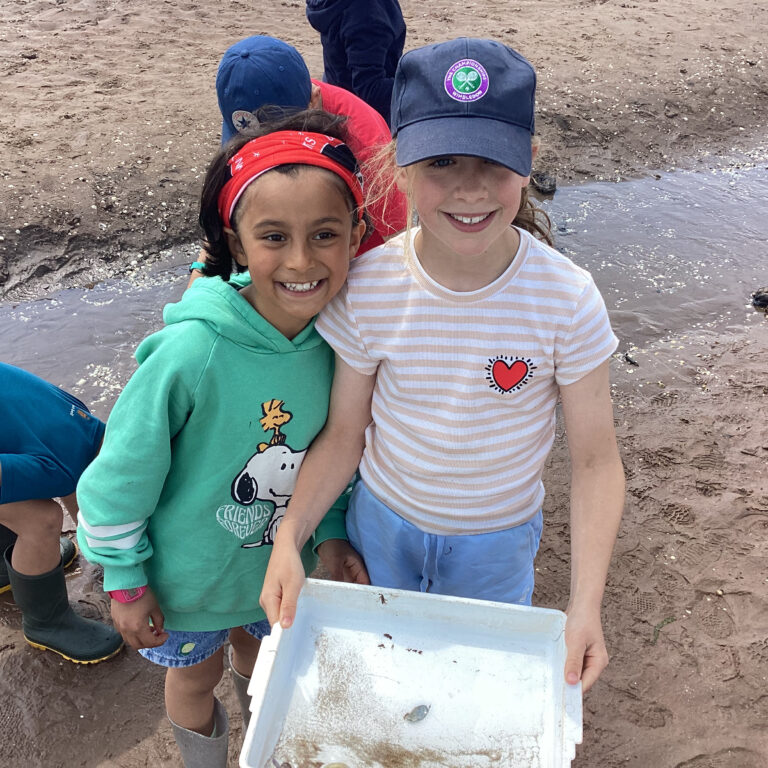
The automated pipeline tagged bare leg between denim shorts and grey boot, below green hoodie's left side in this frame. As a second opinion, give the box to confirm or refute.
[165,648,224,736]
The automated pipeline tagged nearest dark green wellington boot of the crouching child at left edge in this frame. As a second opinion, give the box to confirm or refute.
[4,547,123,664]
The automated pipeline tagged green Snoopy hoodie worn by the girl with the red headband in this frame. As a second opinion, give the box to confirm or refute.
[77,278,347,631]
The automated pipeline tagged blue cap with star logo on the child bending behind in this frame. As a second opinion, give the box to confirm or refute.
[216,35,312,144]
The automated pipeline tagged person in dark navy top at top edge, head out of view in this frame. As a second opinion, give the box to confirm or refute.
[307,0,405,123]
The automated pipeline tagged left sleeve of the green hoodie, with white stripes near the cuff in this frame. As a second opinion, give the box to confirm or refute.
[77,326,205,591]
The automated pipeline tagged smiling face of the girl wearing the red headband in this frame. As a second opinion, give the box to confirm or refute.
[227,166,365,339]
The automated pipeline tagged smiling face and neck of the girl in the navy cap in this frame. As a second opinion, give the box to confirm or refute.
[402,155,530,290]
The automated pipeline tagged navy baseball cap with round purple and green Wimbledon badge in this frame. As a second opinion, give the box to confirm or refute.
[392,37,536,176]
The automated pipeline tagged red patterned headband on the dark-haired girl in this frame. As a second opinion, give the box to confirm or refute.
[219,131,363,227]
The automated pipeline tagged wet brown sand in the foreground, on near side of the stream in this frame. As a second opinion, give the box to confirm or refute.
[0,318,768,768]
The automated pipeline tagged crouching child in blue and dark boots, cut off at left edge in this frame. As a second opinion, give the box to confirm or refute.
[0,363,123,664]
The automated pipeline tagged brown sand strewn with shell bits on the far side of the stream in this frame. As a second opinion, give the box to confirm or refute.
[0,0,768,292]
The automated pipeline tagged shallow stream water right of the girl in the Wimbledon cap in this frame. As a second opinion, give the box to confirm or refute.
[546,167,768,347]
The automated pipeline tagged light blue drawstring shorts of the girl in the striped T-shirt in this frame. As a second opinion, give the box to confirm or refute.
[347,481,542,605]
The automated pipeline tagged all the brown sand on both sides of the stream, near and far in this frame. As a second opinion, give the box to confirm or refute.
[0,0,768,768]
